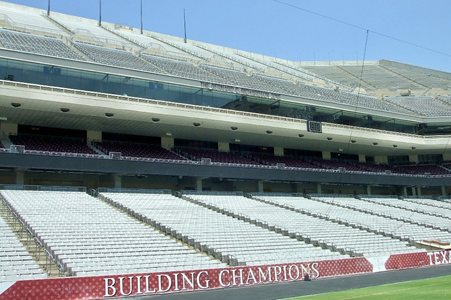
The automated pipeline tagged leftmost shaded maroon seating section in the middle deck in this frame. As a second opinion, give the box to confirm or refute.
[9,135,99,157]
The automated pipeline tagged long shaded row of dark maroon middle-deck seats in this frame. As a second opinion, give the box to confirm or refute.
[0,135,451,176]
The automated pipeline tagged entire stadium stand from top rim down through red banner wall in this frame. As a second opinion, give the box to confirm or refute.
[0,1,451,300]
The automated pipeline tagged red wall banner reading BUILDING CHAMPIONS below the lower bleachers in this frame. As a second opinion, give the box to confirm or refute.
[0,251,451,300]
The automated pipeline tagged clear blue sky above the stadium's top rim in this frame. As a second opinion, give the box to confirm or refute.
[6,0,451,72]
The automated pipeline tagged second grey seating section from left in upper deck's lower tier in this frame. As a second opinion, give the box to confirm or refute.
[73,42,166,74]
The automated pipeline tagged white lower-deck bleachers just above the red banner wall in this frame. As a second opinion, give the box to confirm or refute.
[0,190,451,282]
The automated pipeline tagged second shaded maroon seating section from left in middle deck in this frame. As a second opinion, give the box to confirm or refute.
[93,141,185,161]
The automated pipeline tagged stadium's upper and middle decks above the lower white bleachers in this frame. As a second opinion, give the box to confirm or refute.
[0,2,451,196]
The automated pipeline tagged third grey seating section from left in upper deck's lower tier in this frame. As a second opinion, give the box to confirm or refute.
[141,54,227,84]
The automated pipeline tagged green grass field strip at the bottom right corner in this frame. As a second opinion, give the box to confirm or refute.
[285,276,451,300]
